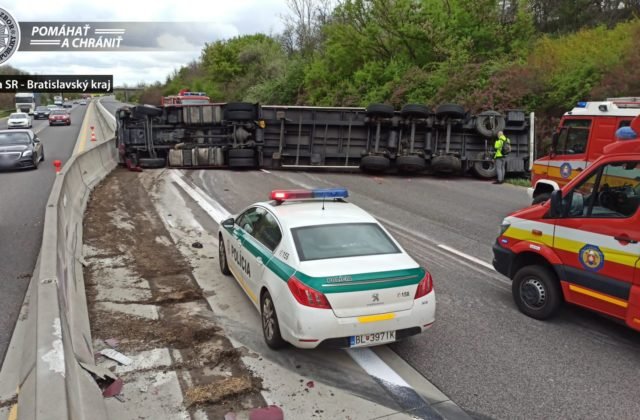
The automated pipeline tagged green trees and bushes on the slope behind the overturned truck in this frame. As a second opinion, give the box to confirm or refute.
[127,0,640,142]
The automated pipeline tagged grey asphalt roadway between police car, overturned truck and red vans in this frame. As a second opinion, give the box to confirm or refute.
[179,170,640,419]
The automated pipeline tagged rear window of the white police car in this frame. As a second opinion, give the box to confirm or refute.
[291,223,400,261]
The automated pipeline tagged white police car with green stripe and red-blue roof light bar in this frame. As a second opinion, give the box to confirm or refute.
[219,188,436,349]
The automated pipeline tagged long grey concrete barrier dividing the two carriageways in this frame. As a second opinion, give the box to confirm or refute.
[18,99,117,420]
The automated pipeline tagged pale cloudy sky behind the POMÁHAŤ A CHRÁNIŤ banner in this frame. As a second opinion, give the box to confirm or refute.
[0,0,288,86]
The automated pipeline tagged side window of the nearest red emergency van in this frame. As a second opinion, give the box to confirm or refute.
[564,161,640,218]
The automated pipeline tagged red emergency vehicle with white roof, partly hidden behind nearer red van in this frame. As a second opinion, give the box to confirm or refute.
[528,98,640,204]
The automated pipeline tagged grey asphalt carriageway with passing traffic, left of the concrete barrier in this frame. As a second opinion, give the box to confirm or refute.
[0,105,87,361]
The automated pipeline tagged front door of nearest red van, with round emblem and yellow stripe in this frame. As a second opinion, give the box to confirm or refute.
[554,162,640,318]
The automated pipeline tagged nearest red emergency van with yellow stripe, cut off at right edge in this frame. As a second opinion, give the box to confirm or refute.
[493,122,640,330]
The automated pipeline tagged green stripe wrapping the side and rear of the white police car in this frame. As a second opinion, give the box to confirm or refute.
[235,232,425,293]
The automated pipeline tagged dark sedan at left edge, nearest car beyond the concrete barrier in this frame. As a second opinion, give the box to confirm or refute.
[0,130,44,169]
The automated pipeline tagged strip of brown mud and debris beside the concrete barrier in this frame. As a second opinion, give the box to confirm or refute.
[84,169,266,418]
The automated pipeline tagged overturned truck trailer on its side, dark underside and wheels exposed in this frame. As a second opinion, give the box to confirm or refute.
[116,102,533,178]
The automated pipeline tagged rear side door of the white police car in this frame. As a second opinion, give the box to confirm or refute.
[242,207,282,296]
